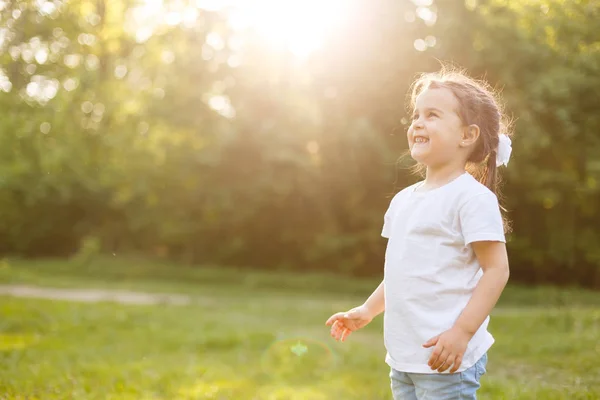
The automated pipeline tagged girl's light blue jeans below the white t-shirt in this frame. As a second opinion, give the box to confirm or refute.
[390,354,487,400]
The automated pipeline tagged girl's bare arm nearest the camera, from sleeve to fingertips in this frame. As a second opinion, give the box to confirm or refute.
[423,241,509,373]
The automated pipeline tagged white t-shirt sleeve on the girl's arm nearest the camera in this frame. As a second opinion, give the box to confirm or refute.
[459,192,506,246]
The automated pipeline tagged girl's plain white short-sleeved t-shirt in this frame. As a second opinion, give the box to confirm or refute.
[381,173,505,373]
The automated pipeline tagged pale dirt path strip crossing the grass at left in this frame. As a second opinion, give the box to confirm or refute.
[0,285,192,306]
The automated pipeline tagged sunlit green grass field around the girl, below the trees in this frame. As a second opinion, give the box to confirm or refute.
[0,257,600,400]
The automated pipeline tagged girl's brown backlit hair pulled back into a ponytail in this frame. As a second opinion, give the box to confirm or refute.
[410,67,511,227]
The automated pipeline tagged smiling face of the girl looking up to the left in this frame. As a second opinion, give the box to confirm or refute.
[407,88,464,167]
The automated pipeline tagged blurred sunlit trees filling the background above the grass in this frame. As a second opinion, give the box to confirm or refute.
[0,0,600,288]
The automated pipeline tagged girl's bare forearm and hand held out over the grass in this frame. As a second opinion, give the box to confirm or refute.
[325,281,385,342]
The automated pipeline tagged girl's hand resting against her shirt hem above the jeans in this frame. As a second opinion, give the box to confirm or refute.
[423,327,472,374]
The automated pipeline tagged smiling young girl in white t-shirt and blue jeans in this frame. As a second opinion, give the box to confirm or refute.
[326,72,511,400]
